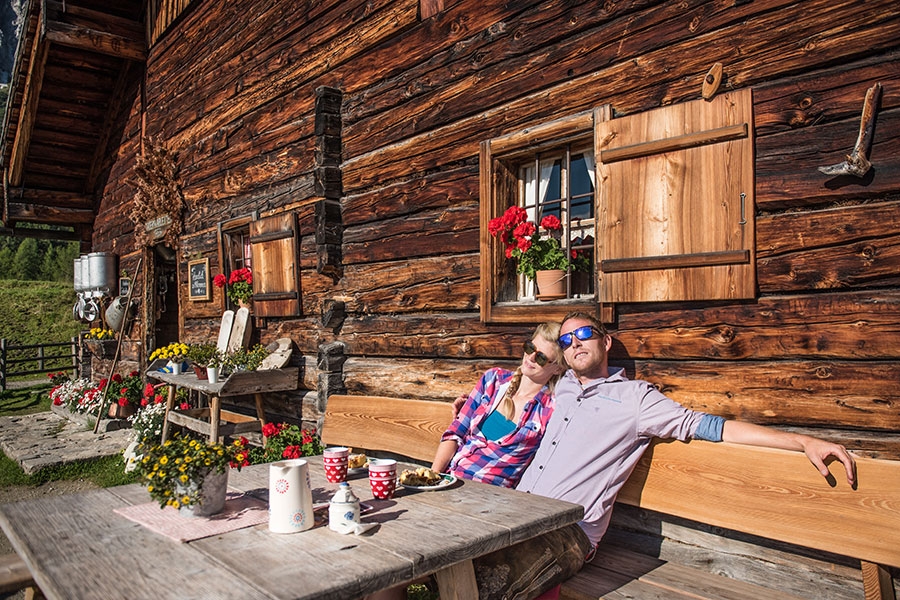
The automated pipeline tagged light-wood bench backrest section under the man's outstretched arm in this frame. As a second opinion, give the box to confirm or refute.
[618,441,900,567]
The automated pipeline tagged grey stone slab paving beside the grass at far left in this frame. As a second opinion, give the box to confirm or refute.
[0,407,131,474]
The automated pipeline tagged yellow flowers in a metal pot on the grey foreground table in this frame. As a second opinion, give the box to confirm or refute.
[135,435,249,516]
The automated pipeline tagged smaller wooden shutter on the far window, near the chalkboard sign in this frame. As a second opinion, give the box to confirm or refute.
[250,212,301,317]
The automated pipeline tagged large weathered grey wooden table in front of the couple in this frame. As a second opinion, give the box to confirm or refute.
[0,457,583,600]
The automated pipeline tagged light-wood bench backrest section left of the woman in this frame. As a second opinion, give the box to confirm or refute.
[321,395,452,461]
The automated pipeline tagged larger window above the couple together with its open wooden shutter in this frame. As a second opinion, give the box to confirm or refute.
[480,89,756,322]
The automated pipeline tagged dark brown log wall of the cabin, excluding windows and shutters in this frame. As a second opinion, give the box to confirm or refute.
[86,0,900,596]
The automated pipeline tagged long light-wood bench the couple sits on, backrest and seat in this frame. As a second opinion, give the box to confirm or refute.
[322,395,900,600]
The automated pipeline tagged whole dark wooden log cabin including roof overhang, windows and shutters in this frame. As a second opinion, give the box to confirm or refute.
[2,0,900,598]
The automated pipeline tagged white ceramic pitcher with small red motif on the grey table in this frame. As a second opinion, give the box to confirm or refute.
[269,458,315,533]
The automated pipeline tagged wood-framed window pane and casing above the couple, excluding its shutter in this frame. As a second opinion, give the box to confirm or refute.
[481,112,598,322]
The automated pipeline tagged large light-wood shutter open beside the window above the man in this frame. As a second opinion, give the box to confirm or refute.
[594,89,756,302]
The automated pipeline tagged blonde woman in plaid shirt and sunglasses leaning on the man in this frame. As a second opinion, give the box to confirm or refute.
[431,323,566,487]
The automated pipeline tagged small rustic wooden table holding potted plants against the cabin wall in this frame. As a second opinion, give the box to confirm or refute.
[147,367,300,442]
